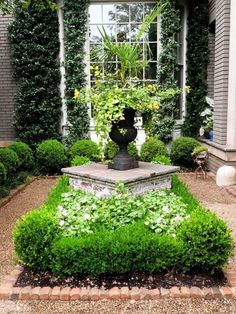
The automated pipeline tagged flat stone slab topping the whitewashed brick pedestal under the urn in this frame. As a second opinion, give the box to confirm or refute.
[61,162,180,184]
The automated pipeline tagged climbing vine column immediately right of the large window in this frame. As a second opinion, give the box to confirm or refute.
[150,0,181,142]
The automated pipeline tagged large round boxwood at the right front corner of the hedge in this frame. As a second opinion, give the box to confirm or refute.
[178,210,233,273]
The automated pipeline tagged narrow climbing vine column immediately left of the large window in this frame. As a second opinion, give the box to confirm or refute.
[64,0,89,144]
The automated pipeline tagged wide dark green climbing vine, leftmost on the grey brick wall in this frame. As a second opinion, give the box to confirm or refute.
[9,0,61,147]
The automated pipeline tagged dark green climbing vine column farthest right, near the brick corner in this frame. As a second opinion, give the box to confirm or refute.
[183,0,209,136]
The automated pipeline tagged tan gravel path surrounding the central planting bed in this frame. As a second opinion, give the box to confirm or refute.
[0,175,236,314]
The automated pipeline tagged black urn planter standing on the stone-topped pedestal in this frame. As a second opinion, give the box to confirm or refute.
[108,109,139,170]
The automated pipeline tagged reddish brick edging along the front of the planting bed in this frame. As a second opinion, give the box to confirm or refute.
[0,265,236,301]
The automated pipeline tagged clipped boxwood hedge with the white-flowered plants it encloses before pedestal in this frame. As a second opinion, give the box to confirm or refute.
[13,176,233,276]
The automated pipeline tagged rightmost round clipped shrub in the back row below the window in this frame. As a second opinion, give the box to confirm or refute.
[170,137,199,167]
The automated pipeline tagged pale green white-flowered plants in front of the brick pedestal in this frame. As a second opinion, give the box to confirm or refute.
[57,183,189,237]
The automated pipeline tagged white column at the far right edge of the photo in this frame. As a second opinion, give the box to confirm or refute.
[227,0,236,148]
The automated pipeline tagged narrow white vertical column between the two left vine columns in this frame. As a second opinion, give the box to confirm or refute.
[57,0,67,136]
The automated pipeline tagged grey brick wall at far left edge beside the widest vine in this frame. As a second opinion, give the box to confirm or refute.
[0,15,17,146]
